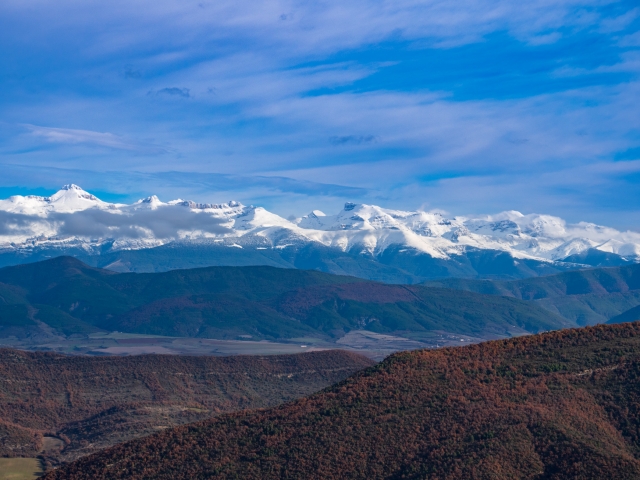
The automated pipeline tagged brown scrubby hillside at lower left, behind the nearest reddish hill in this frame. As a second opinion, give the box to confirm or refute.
[0,349,373,462]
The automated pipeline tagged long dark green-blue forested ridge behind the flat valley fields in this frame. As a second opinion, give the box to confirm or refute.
[0,257,571,346]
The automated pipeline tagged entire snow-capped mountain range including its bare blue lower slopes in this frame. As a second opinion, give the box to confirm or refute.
[0,185,640,283]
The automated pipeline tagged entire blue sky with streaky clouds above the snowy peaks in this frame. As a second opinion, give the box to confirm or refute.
[0,0,640,230]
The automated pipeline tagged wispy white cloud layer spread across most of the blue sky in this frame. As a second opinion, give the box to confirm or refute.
[0,0,640,229]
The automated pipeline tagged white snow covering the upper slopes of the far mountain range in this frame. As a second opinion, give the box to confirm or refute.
[0,185,640,261]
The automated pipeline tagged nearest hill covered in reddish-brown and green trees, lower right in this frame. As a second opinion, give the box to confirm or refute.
[45,323,640,480]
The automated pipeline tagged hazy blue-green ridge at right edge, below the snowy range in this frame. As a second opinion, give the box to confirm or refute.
[425,264,640,326]
